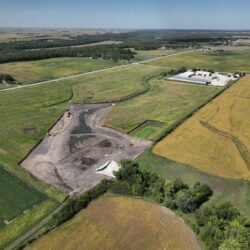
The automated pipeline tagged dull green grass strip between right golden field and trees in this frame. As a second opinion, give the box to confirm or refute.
[138,151,250,216]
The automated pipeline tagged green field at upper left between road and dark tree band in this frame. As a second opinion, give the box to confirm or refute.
[0,57,116,84]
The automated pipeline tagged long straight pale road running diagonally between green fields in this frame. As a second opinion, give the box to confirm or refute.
[0,50,194,92]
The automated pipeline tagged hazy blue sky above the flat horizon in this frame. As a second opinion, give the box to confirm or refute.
[0,0,250,29]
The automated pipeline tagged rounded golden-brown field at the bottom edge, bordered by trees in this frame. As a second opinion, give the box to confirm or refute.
[27,196,200,250]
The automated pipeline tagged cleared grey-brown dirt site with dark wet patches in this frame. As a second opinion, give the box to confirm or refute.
[21,104,152,193]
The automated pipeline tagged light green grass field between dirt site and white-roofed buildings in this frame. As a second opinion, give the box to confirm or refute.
[105,79,221,139]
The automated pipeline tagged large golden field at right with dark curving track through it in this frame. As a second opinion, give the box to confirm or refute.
[153,75,250,180]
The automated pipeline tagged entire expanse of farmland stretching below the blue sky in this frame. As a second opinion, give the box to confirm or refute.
[0,25,250,250]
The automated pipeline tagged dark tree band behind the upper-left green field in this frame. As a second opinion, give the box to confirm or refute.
[0,45,135,63]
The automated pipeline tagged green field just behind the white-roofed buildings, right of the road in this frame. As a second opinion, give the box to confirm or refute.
[147,50,250,72]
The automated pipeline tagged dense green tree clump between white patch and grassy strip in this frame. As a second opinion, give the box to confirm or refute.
[111,161,213,213]
